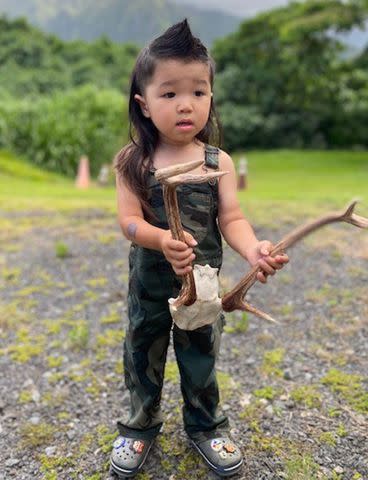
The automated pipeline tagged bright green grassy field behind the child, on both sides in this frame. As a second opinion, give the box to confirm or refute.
[0,150,368,223]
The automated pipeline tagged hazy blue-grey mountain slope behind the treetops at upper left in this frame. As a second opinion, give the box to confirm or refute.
[0,0,241,45]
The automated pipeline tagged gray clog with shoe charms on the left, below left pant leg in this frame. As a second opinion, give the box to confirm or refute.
[110,435,154,480]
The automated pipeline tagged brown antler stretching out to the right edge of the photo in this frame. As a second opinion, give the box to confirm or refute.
[222,201,368,323]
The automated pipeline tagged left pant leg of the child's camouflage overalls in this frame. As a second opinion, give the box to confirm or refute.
[118,295,172,438]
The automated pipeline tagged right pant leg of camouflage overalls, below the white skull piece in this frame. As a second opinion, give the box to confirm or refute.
[173,315,228,440]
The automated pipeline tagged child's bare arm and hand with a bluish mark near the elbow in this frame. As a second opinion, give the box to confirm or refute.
[116,177,196,275]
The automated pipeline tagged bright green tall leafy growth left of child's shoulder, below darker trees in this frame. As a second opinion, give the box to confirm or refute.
[0,85,128,176]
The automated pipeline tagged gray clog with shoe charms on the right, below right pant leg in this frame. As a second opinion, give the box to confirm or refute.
[192,436,243,477]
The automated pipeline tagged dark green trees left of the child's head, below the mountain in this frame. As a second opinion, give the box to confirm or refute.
[0,17,138,96]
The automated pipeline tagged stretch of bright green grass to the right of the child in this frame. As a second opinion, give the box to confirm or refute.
[233,150,368,225]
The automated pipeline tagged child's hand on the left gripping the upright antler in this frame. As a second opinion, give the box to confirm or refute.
[161,230,198,275]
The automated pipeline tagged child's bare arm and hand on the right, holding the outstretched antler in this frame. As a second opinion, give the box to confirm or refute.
[218,152,288,283]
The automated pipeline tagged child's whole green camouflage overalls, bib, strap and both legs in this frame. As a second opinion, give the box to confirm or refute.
[118,145,228,439]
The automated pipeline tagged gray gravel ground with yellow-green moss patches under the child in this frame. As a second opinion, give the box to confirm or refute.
[0,210,368,480]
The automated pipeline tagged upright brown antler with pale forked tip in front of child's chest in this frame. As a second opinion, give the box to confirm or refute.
[155,160,228,307]
